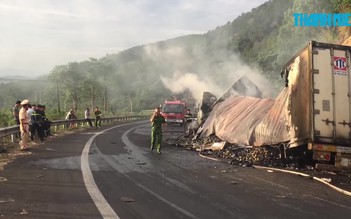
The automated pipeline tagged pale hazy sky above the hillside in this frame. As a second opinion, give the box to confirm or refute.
[0,0,267,76]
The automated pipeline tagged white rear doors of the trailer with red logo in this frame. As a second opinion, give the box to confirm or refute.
[312,46,351,145]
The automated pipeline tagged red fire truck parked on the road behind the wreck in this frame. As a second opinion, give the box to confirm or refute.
[162,100,186,125]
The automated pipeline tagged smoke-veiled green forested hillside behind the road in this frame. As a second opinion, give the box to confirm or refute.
[0,0,350,126]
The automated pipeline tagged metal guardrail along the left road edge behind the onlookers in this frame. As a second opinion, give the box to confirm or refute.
[0,116,149,142]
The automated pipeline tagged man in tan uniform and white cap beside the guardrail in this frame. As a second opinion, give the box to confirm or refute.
[18,99,29,150]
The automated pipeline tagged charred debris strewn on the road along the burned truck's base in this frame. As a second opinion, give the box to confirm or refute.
[164,121,351,190]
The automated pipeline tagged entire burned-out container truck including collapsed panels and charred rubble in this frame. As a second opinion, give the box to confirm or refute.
[172,41,351,169]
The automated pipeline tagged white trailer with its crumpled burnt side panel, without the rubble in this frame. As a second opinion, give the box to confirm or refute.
[201,41,351,167]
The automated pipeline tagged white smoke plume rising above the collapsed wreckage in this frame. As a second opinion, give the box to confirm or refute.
[145,43,272,104]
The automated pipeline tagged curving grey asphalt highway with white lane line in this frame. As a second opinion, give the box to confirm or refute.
[0,122,351,219]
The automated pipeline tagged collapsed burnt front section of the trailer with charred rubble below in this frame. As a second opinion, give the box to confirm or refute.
[166,66,351,173]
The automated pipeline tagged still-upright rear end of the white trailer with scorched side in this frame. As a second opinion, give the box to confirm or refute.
[282,41,351,167]
